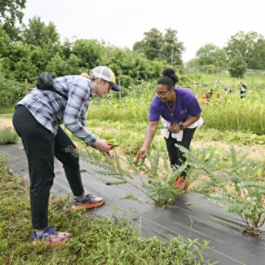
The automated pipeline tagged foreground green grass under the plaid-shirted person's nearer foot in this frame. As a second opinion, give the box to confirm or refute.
[0,156,212,265]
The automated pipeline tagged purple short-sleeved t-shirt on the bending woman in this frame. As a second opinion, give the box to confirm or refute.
[149,87,202,123]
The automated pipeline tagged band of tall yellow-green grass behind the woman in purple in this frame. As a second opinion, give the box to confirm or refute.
[88,87,265,135]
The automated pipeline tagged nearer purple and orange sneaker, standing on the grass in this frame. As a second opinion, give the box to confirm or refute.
[32,226,71,246]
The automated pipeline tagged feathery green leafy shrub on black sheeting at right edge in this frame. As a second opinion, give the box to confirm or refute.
[179,146,265,235]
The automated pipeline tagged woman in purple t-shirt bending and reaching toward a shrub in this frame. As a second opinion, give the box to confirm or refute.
[135,68,202,190]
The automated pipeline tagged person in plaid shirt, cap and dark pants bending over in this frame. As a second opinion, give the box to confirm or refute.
[13,66,121,246]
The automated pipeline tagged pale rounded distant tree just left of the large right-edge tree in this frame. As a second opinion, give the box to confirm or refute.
[196,43,226,66]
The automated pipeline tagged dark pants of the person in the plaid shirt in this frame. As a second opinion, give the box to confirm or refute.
[13,105,84,229]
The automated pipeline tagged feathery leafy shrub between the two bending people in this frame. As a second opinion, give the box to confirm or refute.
[65,147,187,206]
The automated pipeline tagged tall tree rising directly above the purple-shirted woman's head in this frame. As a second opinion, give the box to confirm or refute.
[133,28,185,65]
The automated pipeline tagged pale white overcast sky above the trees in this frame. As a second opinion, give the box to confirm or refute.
[23,0,265,62]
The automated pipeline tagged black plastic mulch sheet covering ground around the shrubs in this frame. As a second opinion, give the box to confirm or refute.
[0,143,265,265]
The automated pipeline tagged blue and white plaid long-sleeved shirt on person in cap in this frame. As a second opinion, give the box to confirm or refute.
[18,75,97,145]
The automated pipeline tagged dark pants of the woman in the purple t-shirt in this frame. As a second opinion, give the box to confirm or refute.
[165,128,196,178]
